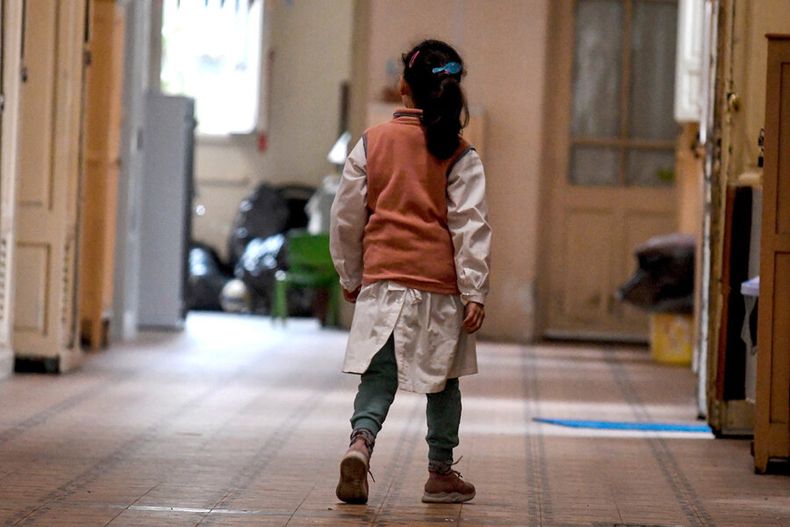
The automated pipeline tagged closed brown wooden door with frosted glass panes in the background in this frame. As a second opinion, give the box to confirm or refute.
[541,0,679,340]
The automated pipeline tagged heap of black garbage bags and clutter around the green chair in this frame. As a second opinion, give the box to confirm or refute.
[192,176,338,316]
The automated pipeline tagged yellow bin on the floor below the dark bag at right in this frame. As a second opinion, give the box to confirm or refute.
[650,313,694,366]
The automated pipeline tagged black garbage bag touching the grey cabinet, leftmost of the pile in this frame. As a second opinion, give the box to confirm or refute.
[185,242,233,311]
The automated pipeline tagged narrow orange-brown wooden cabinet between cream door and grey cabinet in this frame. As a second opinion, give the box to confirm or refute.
[79,0,124,349]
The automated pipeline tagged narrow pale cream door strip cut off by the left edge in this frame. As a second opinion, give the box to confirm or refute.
[0,0,23,378]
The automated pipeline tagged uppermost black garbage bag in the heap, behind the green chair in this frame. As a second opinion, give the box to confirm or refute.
[228,183,290,266]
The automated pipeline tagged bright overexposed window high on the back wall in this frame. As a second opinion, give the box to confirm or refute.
[161,0,263,135]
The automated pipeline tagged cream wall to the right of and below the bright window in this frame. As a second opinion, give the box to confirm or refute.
[193,0,354,260]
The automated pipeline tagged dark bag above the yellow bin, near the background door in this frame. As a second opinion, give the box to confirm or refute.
[618,234,695,313]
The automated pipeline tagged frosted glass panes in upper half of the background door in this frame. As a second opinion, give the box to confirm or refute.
[570,0,678,186]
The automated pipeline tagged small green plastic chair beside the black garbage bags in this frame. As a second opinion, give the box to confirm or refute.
[271,230,340,326]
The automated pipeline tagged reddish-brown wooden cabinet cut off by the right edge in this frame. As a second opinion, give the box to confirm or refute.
[754,35,790,472]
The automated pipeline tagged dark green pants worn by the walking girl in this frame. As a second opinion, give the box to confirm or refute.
[351,336,461,462]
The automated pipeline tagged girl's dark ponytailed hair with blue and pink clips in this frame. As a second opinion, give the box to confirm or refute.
[403,40,469,159]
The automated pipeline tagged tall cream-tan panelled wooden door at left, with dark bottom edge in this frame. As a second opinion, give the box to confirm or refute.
[13,0,86,371]
